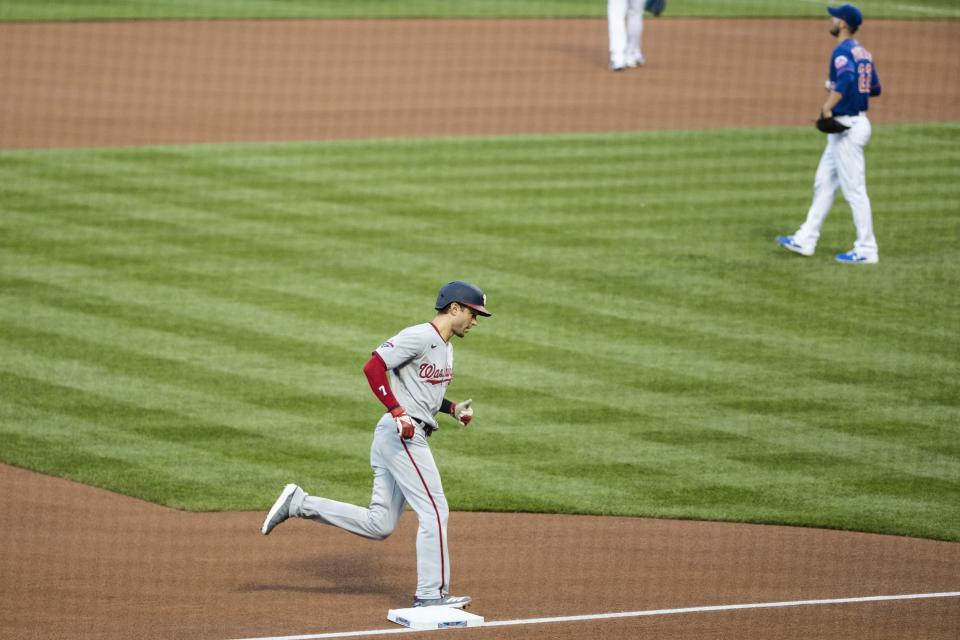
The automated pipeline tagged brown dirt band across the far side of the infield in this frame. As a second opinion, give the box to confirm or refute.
[0,18,960,148]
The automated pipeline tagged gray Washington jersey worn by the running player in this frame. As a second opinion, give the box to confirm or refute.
[376,322,453,429]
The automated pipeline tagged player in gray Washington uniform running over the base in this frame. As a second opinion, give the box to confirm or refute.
[261,281,490,608]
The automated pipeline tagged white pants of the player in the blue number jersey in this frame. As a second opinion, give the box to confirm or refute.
[793,113,878,256]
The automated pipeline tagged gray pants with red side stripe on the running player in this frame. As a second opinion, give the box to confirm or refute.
[290,413,450,599]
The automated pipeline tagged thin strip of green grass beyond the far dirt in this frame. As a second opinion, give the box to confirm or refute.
[0,0,960,20]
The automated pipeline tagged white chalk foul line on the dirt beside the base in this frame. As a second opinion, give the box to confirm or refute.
[232,591,960,640]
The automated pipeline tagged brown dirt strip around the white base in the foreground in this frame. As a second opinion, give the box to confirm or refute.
[0,465,960,640]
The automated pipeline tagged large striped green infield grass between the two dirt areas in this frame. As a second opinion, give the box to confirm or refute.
[0,124,960,540]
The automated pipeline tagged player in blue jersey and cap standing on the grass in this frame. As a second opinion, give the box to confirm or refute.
[777,4,881,264]
